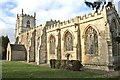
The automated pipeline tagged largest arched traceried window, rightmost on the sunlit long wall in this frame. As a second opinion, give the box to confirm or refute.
[85,27,98,54]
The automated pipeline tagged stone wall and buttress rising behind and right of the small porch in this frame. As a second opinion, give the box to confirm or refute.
[19,29,36,62]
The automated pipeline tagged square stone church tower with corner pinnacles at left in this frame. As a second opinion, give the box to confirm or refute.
[15,9,36,44]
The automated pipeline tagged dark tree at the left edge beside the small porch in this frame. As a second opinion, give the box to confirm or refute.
[0,36,9,59]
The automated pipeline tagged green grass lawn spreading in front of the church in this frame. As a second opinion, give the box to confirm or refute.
[2,61,118,78]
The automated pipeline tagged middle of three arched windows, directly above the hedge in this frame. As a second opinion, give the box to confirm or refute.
[64,32,73,51]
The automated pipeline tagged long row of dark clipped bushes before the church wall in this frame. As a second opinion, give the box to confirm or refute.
[50,59,82,71]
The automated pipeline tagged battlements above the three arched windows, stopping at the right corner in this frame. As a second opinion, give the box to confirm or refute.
[47,12,101,30]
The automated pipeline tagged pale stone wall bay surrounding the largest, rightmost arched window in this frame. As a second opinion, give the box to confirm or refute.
[80,15,108,65]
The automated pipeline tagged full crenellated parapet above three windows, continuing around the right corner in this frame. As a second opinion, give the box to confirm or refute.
[42,7,115,31]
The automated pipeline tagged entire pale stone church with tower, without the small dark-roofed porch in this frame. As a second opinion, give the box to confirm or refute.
[12,7,120,70]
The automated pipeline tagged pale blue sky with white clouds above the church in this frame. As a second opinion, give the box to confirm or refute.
[0,0,120,43]
